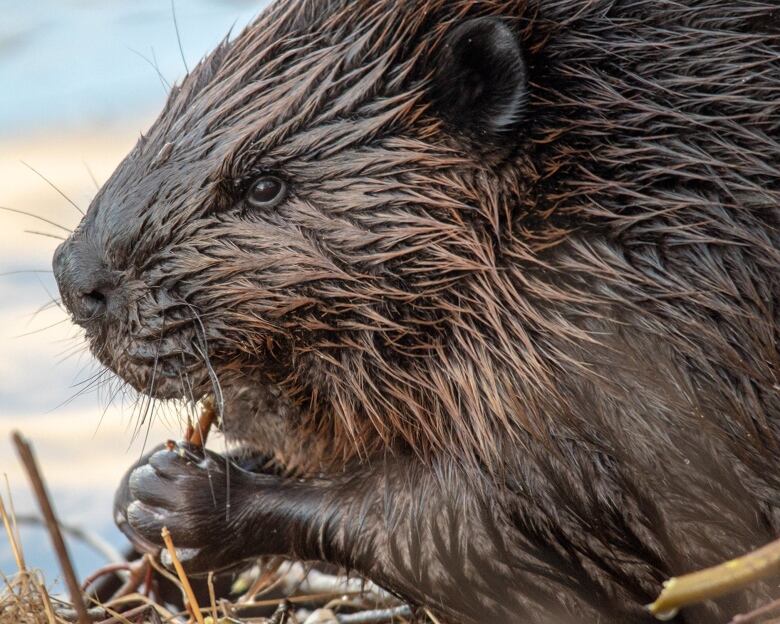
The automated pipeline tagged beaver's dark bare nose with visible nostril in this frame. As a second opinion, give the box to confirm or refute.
[52,239,115,327]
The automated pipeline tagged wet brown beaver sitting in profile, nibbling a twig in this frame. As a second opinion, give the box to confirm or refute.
[54,0,780,624]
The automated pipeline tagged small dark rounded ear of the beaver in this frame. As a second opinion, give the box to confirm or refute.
[432,17,528,138]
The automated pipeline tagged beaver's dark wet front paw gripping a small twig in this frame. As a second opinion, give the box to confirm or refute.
[115,444,262,575]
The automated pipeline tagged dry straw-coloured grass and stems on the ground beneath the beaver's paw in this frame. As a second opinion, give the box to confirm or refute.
[0,478,426,624]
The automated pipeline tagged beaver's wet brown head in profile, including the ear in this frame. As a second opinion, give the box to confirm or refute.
[54,2,527,456]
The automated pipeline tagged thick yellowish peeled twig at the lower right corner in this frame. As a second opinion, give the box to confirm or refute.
[647,540,780,618]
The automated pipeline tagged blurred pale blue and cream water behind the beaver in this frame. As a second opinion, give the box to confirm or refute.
[0,0,267,591]
